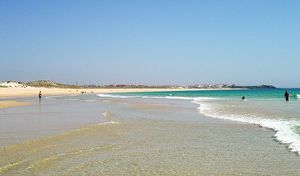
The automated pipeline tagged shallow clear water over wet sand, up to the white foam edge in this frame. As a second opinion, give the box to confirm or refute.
[0,96,300,176]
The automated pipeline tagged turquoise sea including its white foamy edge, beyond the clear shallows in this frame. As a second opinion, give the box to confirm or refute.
[98,89,300,154]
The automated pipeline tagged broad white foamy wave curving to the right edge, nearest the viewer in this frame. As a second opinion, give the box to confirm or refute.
[192,101,300,155]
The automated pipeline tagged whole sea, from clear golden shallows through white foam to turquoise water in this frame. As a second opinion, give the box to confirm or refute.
[0,89,300,176]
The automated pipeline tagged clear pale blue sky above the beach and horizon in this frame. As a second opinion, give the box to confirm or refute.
[0,0,300,87]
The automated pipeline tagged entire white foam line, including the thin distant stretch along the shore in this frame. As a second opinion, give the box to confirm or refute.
[98,94,300,155]
